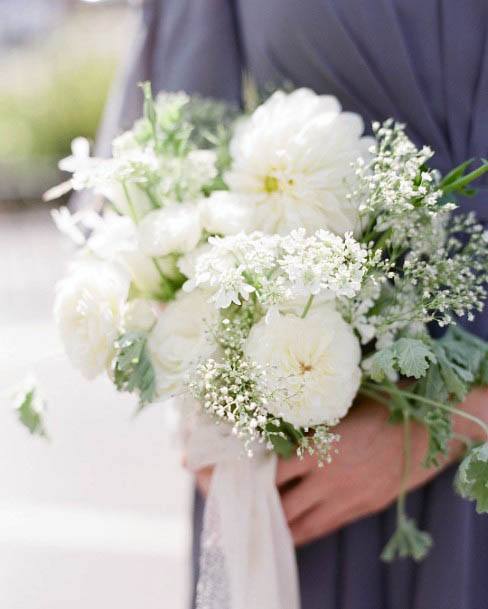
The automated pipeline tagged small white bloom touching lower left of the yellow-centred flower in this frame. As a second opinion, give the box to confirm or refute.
[199,190,252,235]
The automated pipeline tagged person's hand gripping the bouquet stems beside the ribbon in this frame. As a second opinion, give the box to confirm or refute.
[277,402,448,545]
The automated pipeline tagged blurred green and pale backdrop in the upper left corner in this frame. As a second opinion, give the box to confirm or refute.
[0,0,134,204]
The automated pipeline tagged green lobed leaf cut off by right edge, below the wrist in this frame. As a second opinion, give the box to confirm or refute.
[454,442,488,514]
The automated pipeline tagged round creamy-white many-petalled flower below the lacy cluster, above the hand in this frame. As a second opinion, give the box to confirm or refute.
[245,306,361,427]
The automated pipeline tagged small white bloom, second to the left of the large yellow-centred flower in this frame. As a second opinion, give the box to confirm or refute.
[139,203,202,256]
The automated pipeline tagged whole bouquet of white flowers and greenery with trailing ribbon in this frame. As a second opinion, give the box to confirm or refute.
[46,84,488,609]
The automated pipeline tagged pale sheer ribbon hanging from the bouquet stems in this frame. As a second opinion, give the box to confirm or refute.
[187,416,300,609]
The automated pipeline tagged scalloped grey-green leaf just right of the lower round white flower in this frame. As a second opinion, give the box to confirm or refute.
[369,338,435,382]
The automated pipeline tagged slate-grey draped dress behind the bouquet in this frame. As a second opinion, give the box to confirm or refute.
[102,0,488,609]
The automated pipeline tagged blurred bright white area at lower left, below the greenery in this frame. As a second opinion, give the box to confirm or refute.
[0,207,190,609]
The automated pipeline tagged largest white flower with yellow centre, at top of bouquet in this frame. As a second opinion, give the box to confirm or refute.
[225,89,372,235]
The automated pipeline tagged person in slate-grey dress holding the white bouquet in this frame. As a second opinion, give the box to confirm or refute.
[92,0,488,609]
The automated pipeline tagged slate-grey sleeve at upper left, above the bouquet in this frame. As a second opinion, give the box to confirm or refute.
[96,0,242,156]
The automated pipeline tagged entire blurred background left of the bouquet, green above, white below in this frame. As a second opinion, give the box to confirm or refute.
[0,0,190,609]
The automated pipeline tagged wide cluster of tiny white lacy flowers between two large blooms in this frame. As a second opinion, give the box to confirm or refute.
[184,229,368,309]
